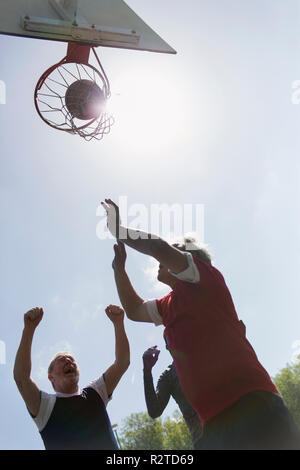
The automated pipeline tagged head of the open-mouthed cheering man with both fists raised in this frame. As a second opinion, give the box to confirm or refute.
[49,354,79,393]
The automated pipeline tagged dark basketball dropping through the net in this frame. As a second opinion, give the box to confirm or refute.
[65,80,105,121]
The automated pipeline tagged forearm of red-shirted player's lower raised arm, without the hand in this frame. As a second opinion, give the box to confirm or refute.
[114,269,144,320]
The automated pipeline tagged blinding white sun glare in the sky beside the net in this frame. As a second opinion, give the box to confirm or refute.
[108,69,187,151]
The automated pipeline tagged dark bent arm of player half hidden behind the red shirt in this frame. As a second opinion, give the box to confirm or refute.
[143,346,171,419]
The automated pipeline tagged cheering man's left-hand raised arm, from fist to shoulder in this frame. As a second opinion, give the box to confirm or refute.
[14,307,44,416]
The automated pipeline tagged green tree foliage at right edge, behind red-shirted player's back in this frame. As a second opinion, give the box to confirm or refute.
[274,355,300,428]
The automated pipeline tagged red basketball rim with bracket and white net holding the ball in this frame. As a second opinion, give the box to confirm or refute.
[34,43,114,140]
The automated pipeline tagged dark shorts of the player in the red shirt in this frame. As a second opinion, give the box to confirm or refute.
[198,391,300,450]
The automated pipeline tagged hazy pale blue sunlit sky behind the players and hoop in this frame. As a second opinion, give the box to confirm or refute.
[0,0,300,449]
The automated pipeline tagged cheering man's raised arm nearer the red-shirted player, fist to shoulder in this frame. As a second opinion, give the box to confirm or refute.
[104,305,130,396]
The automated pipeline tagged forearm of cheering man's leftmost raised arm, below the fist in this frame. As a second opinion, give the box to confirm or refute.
[14,328,34,382]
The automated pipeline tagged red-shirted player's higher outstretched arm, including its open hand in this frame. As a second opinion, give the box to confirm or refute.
[101,199,188,273]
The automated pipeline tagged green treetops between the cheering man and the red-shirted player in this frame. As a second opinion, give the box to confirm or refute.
[119,411,193,450]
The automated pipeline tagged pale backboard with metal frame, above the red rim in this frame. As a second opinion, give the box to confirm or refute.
[0,0,176,54]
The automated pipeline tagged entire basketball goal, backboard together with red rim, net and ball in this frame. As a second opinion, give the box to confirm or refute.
[0,0,176,140]
